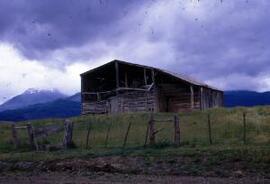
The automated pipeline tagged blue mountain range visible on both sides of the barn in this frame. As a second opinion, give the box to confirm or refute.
[0,89,270,121]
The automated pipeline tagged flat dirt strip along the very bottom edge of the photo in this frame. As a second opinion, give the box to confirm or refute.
[0,173,270,184]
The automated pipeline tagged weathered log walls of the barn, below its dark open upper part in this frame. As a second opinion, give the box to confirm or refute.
[82,85,223,114]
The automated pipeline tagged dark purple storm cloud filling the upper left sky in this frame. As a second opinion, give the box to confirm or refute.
[0,0,148,60]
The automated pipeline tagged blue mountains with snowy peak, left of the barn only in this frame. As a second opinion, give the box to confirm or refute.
[0,89,81,121]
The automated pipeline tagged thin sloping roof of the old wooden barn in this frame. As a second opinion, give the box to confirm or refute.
[81,60,222,91]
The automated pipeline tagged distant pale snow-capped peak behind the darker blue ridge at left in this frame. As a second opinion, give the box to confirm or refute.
[0,88,66,111]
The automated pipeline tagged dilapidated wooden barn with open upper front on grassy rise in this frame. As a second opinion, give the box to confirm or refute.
[81,60,223,114]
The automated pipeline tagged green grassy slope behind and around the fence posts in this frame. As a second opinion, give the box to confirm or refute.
[0,106,270,160]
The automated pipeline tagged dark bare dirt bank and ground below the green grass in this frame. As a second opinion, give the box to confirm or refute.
[0,156,270,184]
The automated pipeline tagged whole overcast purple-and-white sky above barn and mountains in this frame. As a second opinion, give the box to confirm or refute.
[0,0,270,103]
